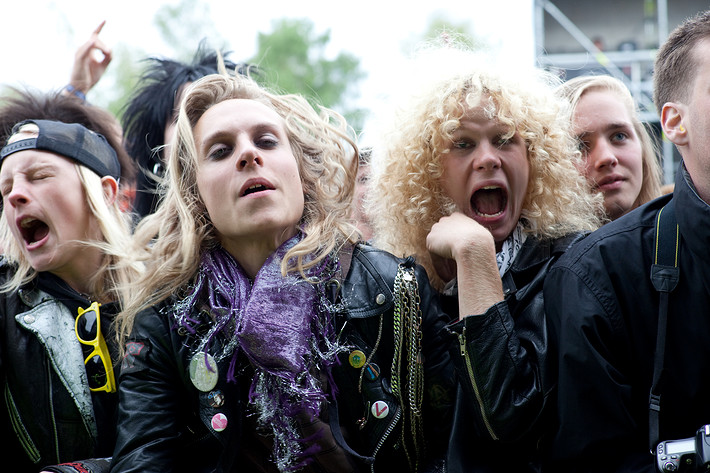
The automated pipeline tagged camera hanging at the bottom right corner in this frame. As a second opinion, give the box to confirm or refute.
[656,424,710,473]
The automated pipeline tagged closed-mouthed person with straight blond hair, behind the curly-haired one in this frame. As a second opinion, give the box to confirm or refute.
[557,75,661,220]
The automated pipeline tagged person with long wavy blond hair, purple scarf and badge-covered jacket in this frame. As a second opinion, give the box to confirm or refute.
[112,75,454,472]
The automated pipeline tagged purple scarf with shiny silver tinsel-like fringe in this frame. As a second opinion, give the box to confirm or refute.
[173,234,344,471]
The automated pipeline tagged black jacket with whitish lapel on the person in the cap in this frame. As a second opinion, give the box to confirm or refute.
[0,261,118,472]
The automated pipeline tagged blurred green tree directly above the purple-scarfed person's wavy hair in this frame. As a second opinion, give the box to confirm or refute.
[248,18,365,131]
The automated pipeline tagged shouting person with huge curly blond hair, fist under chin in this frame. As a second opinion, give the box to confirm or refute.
[369,47,601,471]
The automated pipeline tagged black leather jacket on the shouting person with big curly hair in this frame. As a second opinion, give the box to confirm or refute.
[447,235,577,473]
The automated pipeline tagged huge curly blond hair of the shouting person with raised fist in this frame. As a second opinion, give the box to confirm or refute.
[366,46,601,288]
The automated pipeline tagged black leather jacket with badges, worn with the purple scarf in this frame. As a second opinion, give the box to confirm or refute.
[111,245,453,473]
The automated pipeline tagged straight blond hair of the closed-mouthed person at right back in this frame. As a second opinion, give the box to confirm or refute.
[557,75,661,214]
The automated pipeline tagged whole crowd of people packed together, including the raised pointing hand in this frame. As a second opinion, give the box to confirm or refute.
[0,11,710,473]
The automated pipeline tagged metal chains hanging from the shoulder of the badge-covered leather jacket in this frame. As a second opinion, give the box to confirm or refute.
[392,264,424,471]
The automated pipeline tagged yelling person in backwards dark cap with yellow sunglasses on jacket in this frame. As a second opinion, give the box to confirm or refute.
[0,120,140,472]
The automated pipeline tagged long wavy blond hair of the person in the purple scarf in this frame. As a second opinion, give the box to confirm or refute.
[117,74,358,346]
